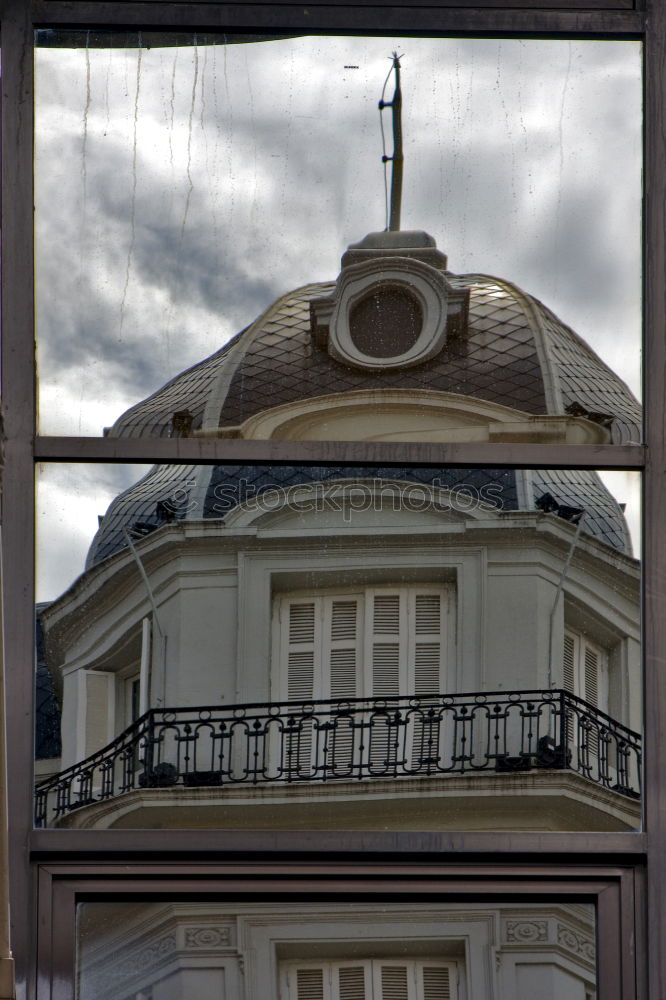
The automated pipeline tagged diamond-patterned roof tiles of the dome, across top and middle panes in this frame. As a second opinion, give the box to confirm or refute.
[94,275,641,565]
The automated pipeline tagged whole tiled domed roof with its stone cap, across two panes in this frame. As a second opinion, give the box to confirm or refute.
[87,233,641,567]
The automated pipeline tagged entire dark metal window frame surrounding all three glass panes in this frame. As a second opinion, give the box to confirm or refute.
[1,0,666,1000]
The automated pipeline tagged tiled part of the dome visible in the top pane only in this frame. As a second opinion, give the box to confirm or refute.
[109,254,641,444]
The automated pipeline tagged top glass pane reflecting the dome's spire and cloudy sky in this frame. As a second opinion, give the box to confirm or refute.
[36,31,642,444]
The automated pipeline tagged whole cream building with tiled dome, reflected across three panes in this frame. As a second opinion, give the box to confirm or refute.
[31,231,642,1000]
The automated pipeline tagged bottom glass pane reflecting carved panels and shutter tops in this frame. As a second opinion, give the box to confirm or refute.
[76,901,597,1000]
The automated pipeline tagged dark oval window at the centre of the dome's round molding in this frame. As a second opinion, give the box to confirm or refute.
[349,286,423,358]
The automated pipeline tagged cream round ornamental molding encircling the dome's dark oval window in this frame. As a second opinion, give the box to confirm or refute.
[327,257,451,370]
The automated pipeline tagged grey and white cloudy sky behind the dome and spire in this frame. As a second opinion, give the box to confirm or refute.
[36,36,641,596]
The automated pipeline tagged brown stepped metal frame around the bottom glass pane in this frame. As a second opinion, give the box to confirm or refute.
[39,857,638,1000]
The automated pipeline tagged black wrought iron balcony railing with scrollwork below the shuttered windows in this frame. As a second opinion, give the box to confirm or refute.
[35,690,641,826]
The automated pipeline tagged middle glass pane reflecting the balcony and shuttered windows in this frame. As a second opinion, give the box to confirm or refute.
[36,465,642,830]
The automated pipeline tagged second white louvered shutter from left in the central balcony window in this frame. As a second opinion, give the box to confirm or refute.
[321,596,361,777]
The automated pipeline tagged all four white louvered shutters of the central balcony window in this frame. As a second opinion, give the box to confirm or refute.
[273,586,453,779]
